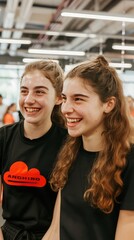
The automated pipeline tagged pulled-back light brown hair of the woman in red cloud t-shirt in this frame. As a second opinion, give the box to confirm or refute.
[21,60,65,127]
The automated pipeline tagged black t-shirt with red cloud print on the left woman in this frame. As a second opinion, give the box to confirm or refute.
[0,121,66,233]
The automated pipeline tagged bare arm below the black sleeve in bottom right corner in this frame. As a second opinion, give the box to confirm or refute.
[115,210,134,240]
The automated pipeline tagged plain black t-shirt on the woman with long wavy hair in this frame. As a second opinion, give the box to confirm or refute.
[60,144,134,240]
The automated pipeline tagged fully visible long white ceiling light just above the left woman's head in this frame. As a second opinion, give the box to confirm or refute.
[28,48,85,56]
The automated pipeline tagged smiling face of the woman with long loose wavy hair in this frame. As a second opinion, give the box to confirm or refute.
[62,78,105,137]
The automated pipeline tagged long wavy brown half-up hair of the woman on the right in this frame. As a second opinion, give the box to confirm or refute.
[50,56,134,213]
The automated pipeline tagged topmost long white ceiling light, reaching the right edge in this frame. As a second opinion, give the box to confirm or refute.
[61,9,134,23]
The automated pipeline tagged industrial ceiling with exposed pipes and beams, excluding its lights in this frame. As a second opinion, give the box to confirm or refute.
[0,0,134,69]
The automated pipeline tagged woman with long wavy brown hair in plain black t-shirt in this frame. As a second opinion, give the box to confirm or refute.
[46,56,134,240]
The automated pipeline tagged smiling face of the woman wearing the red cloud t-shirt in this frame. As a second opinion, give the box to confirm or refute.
[19,70,58,126]
